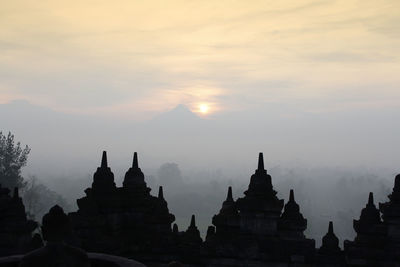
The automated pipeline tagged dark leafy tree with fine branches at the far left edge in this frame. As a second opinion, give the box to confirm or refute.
[0,132,31,189]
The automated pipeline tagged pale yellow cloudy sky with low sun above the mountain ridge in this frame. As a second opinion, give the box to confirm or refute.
[0,0,400,118]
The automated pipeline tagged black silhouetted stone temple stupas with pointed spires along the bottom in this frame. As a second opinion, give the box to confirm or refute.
[0,151,400,267]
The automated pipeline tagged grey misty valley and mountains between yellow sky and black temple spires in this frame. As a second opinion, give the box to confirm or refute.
[0,101,400,248]
